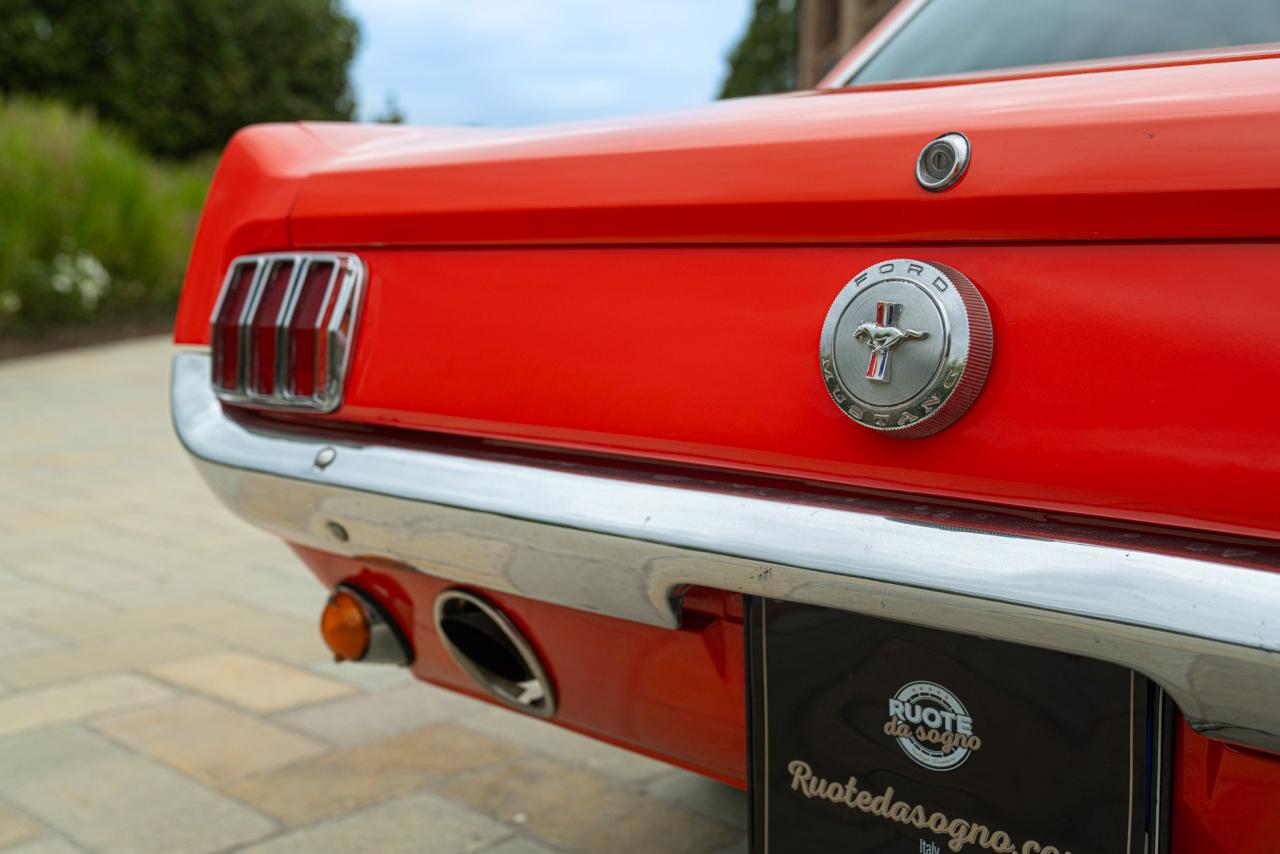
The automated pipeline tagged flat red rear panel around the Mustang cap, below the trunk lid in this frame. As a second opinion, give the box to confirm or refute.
[334,243,1280,535]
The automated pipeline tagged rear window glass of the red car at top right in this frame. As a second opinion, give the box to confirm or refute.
[849,0,1280,83]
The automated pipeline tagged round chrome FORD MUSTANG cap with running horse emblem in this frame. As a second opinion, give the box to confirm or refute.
[818,259,992,438]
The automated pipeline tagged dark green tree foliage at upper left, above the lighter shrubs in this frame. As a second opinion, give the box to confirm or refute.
[0,0,358,157]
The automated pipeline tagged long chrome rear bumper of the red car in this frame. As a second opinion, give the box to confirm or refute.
[173,352,1280,750]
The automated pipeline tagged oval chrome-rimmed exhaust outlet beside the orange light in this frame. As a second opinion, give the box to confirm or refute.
[435,590,556,718]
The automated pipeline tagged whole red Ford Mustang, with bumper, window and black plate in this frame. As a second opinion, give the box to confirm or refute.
[173,0,1280,854]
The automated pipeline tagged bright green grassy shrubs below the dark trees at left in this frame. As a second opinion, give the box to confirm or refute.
[0,99,214,334]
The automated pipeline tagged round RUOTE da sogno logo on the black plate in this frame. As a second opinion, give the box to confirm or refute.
[884,681,982,771]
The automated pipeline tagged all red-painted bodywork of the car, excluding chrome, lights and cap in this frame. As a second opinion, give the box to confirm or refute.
[175,8,1280,854]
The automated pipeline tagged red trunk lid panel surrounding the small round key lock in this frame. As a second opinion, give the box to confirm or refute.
[291,58,1280,247]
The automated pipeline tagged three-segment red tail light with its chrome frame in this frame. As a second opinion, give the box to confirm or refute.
[210,252,365,412]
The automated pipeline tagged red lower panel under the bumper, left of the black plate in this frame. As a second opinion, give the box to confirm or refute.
[294,545,746,787]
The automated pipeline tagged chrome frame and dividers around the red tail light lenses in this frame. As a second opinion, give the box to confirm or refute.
[209,252,366,412]
